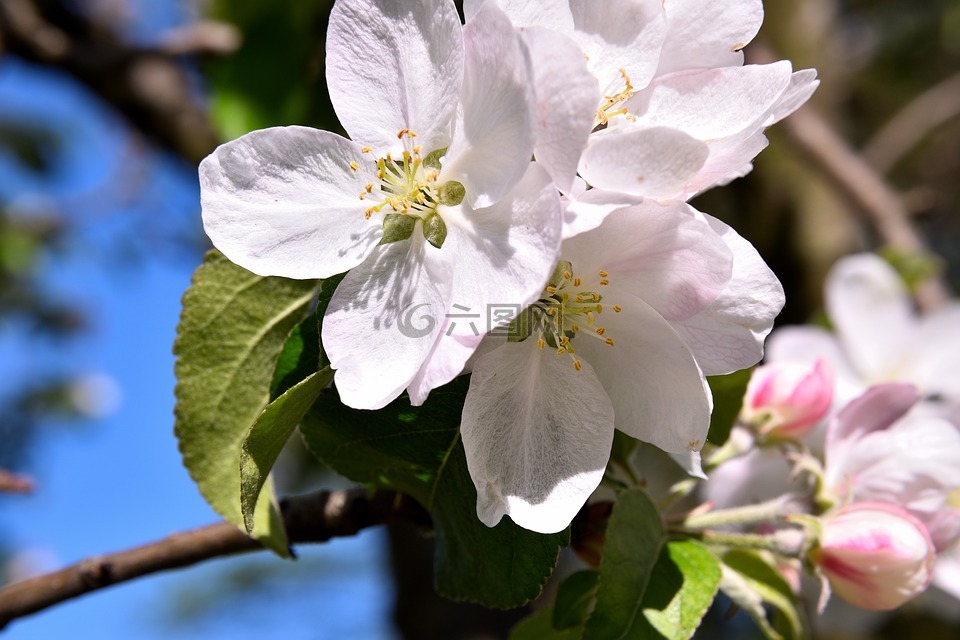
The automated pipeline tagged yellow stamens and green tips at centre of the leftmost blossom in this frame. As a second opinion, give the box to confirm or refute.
[350,129,465,249]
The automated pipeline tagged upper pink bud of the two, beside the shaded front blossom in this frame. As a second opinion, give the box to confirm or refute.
[740,359,833,438]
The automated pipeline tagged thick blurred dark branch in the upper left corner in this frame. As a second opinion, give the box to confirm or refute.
[0,0,218,163]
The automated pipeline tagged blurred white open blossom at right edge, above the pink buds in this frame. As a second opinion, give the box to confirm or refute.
[767,253,960,424]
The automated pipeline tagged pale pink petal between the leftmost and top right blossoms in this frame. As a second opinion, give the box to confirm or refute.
[523,27,600,191]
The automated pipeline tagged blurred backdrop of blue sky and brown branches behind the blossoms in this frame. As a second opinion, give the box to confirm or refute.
[0,0,960,640]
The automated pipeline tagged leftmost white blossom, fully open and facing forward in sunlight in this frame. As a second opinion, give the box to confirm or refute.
[200,0,563,408]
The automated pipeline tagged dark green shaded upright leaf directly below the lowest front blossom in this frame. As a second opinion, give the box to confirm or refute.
[583,489,666,640]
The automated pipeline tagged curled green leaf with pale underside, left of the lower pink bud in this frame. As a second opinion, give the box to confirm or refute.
[720,550,806,640]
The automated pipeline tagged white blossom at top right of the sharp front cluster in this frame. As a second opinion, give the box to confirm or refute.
[465,0,818,221]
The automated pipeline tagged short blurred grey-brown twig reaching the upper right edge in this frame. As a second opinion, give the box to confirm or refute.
[863,73,960,173]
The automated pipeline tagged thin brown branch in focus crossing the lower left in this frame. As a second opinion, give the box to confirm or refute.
[0,488,429,629]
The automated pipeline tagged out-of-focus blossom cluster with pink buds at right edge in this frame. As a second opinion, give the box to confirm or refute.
[706,254,960,610]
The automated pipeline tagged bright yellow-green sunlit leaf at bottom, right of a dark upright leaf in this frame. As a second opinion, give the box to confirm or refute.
[629,540,720,640]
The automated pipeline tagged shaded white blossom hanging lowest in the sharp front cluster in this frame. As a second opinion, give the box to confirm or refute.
[461,202,783,533]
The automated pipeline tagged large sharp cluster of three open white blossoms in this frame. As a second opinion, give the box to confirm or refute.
[200,0,817,533]
